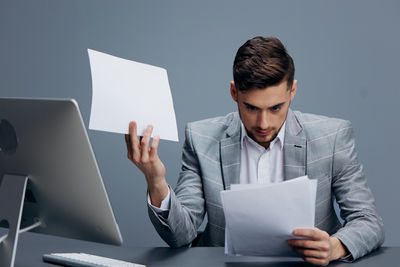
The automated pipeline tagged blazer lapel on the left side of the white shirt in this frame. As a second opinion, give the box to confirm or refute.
[220,113,240,190]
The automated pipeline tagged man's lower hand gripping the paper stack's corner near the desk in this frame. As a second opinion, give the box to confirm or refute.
[287,228,348,266]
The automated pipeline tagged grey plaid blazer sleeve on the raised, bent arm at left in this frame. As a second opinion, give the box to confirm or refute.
[148,124,205,247]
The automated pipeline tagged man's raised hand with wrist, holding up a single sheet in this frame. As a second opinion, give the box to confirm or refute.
[125,121,168,207]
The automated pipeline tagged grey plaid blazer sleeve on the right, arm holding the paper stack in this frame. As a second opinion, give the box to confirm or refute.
[332,121,384,260]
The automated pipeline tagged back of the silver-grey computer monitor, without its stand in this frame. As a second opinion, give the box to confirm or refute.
[0,98,122,266]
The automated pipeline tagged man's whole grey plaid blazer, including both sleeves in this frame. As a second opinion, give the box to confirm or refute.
[148,110,384,259]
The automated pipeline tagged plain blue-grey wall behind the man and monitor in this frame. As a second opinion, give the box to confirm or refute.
[0,0,400,249]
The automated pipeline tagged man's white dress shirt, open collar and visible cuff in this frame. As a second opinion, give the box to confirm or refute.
[147,122,286,213]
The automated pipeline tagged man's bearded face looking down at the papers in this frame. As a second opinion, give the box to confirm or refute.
[231,80,297,151]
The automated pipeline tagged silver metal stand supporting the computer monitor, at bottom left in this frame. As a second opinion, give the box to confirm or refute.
[0,174,41,267]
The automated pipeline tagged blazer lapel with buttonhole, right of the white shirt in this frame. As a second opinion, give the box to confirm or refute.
[283,109,307,180]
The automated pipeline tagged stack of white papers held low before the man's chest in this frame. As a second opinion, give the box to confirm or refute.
[221,176,317,257]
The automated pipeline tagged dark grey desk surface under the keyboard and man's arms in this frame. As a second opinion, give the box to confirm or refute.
[15,234,400,267]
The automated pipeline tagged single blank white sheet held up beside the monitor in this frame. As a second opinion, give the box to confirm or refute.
[88,49,178,141]
